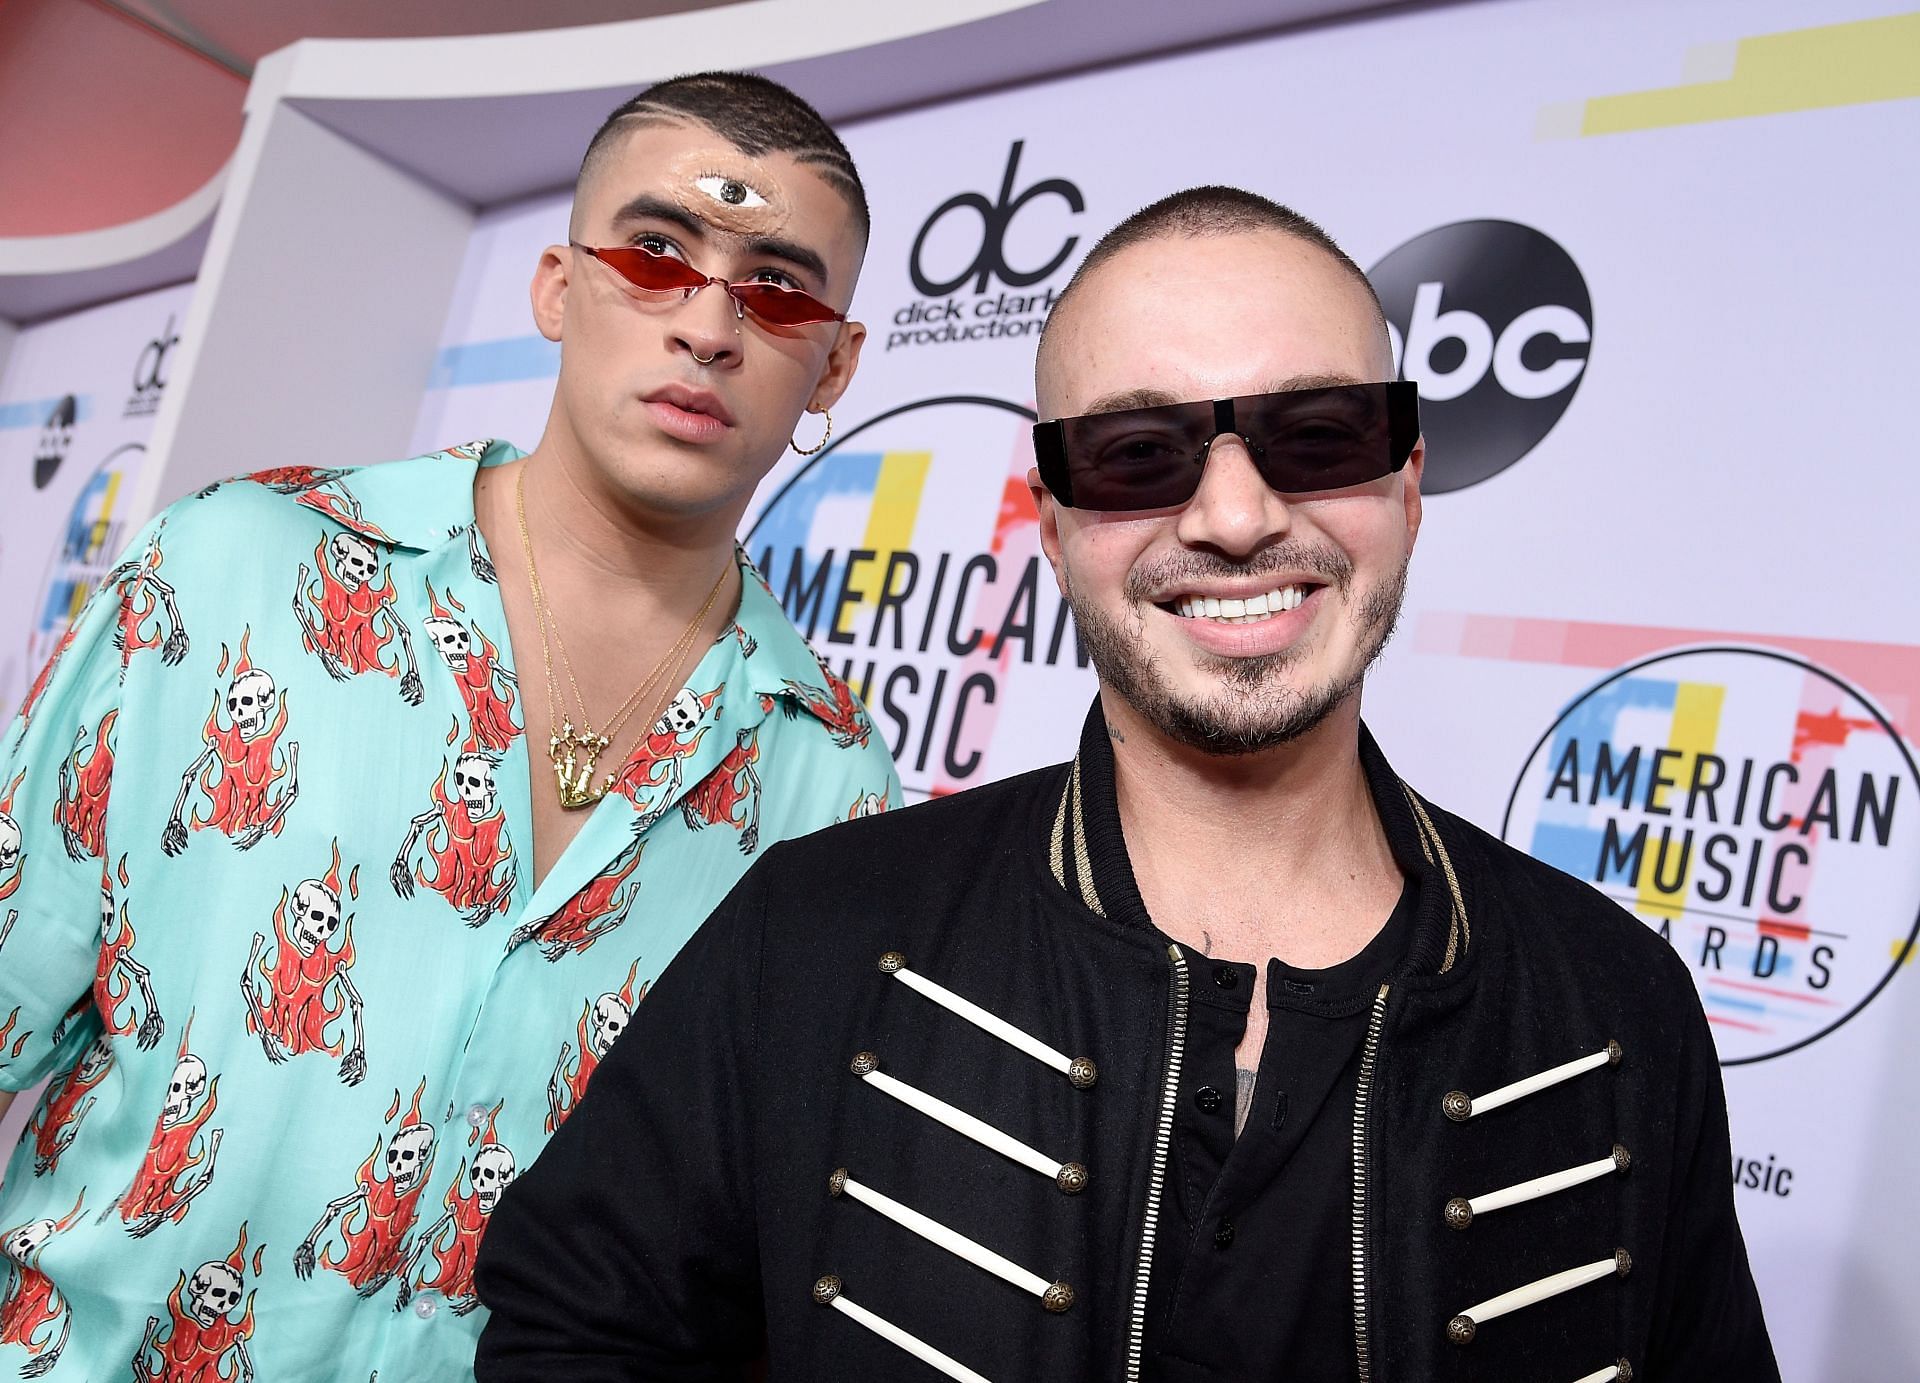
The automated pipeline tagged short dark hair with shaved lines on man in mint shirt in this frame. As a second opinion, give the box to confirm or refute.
[574,71,874,240]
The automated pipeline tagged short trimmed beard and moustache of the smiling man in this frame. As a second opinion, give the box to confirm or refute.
[1066,544,1407,755]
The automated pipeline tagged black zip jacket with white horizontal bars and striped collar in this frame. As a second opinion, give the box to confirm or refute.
[476,707,1778,1383]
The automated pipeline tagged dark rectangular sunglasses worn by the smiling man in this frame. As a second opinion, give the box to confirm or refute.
[1033,380,1421,511]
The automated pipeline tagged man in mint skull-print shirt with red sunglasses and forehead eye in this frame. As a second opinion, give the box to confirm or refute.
[0,73,899,1383]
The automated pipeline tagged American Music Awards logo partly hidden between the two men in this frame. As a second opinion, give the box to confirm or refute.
[741,396,1094,799]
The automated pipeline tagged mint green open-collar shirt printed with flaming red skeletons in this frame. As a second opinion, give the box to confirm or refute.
[0,442,900,1383]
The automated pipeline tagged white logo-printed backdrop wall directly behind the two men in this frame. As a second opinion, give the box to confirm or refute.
[405,0,1920,1381]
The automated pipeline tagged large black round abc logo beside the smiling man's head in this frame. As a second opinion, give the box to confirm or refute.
[1367,221,1594,494]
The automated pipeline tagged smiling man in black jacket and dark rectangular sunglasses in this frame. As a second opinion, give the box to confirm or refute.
[478,188,1778,1383]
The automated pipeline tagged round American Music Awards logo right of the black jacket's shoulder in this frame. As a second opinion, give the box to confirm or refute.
[1501,647,1920,1066]
